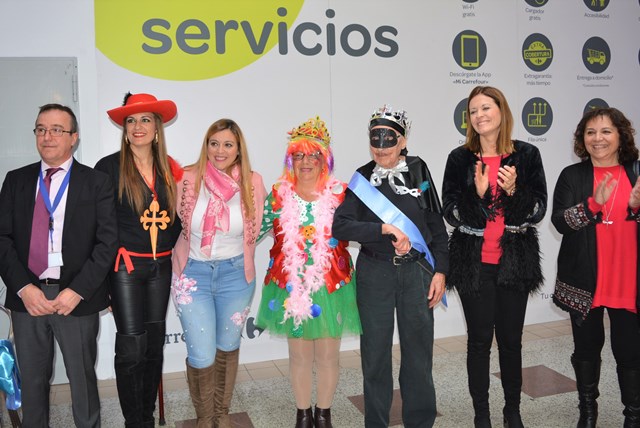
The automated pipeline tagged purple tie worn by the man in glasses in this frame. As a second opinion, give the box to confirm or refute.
[29,168,62,276]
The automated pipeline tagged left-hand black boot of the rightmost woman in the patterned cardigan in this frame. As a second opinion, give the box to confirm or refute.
[571,356,601,428]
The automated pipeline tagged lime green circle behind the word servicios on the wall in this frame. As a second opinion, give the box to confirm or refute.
[94,0,304,81]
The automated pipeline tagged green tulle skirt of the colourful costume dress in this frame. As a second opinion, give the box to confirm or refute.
[256,275,362,340]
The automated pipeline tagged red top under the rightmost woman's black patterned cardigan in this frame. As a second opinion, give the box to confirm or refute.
[589,165,638,313]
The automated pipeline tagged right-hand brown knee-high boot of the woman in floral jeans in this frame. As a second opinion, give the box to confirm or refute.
[213,348,240,428]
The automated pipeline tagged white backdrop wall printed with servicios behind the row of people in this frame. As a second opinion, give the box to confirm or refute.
[0,0,640,378]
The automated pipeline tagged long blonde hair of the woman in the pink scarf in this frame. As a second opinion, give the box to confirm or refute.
[187,119,256,219]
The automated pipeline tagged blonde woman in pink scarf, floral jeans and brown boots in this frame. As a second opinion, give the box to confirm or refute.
[171,119,266,427]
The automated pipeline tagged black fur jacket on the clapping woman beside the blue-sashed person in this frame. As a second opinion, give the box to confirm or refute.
[442,140,547,294]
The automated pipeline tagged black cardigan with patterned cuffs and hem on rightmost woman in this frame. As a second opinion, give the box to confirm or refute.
[551,160,640,319]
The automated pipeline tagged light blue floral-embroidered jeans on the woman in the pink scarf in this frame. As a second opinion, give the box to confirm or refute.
[172,254,256,369]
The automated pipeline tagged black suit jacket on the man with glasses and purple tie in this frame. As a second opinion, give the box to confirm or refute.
[0,160,118,316]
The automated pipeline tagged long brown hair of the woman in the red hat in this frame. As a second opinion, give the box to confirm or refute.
[118,113,176,222]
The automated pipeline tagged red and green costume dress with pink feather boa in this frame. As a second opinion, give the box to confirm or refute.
[255,179,362,340]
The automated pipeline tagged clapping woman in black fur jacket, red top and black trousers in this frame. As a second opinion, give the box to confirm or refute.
[442,86,547,428]
